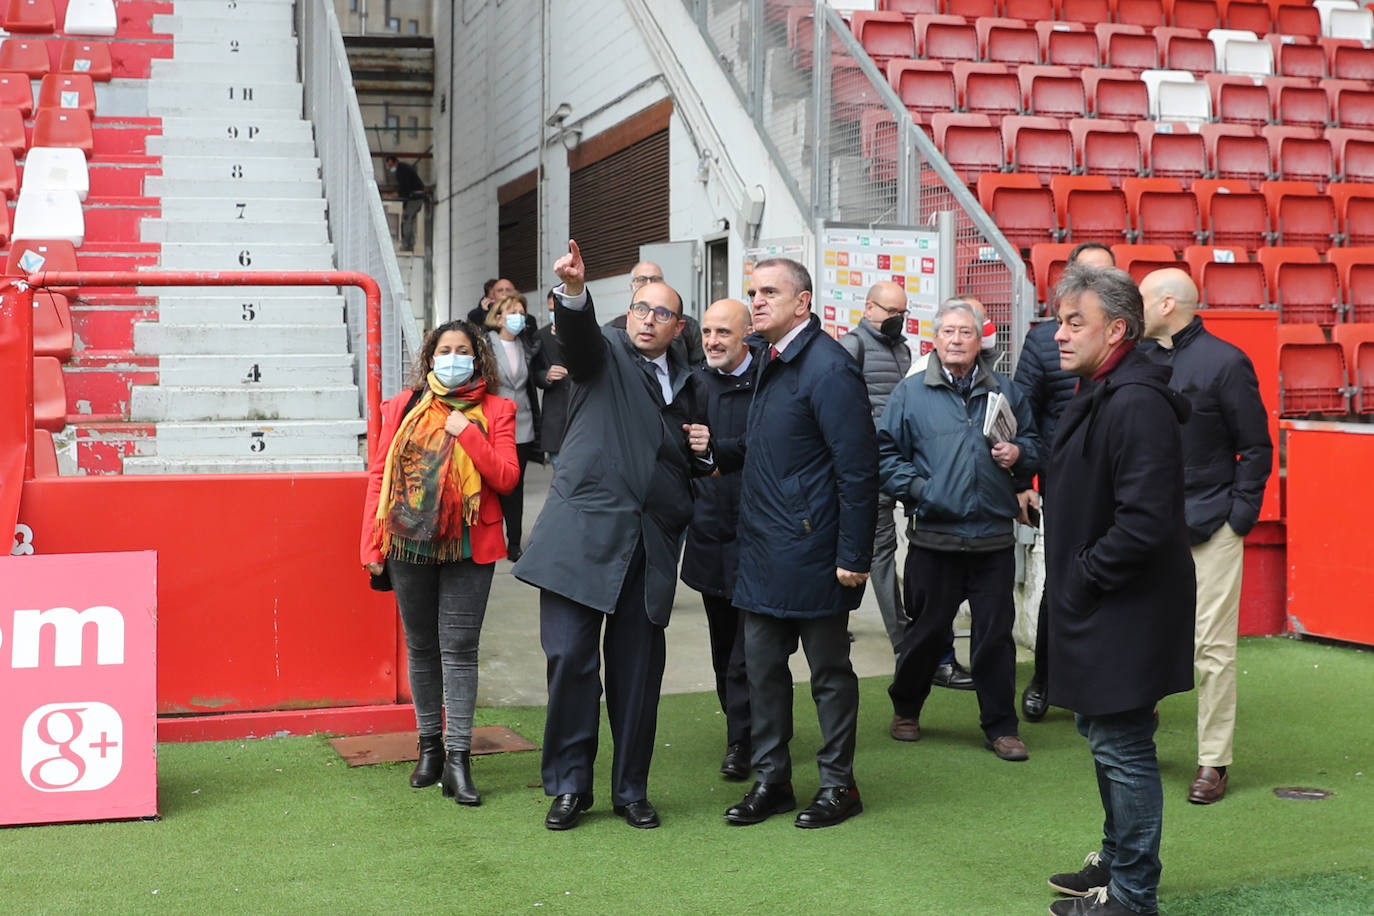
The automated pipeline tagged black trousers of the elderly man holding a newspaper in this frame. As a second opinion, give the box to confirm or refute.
[888,545,1017,739]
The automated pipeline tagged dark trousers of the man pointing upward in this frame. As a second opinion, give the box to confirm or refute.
[539,545,665,805]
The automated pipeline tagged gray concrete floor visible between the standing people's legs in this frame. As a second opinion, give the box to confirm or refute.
[477,464,917,706]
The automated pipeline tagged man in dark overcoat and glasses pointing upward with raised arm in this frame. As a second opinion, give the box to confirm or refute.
[514,242,712,829]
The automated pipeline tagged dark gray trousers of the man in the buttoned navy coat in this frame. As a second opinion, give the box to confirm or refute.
[745,611,859,787]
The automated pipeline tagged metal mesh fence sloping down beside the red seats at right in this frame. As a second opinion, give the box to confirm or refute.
[683,0,1035,369]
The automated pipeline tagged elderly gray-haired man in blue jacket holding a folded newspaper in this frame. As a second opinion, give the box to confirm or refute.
[878,299,1039,761]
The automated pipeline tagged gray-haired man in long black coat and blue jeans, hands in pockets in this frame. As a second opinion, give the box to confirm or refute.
[1046,266,1194,916]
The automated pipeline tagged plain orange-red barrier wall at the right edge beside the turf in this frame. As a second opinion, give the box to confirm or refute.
[1283,420,1374,645]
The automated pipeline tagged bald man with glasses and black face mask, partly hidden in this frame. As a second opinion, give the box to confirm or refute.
[840,280,911,652]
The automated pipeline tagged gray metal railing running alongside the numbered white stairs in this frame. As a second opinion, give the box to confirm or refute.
[295,0,420,397]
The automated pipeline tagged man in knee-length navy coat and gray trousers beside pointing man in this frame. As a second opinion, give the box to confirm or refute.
[714,258,878,828]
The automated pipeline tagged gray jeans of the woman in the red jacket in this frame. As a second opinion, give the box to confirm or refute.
[386,559,496,751]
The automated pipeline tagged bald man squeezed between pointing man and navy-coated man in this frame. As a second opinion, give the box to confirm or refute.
[682,299,757,780]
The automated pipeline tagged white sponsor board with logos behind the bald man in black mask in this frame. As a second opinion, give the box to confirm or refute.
[815,222,952,354]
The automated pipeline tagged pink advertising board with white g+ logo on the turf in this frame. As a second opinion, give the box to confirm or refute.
[0,551,158,824]
